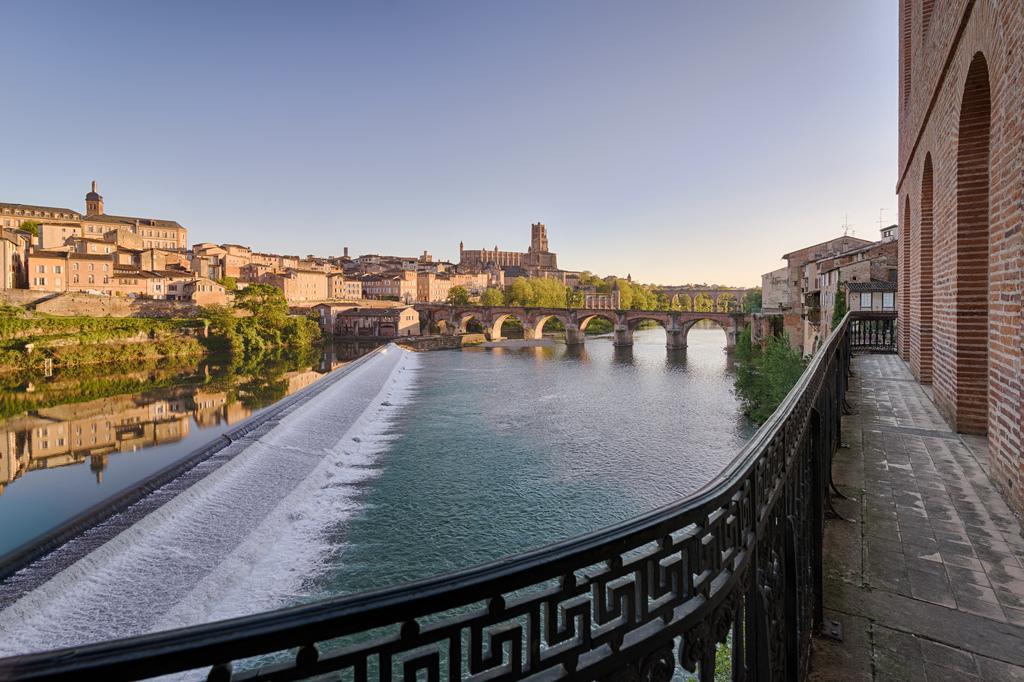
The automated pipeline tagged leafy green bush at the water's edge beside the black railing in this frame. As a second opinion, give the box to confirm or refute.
[734,327,807,424]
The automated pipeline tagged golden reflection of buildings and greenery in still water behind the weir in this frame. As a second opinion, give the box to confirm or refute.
[0,342,378,494]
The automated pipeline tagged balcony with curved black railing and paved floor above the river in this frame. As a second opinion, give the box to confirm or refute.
[0,313,1024,681]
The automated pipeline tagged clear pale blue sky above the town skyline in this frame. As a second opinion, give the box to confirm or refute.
[0,0,897,285]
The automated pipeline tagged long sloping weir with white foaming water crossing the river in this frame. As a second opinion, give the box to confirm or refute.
[0,346,418,656]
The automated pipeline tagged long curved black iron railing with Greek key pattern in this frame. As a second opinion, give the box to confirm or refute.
[0,315,888,681]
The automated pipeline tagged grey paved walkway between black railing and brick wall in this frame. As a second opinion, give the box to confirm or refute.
[811,355,1024,681]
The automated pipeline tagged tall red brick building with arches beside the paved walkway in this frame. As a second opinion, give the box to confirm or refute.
[896,0,1024,511]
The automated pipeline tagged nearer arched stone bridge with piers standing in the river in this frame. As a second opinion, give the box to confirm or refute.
[415,303,748,350]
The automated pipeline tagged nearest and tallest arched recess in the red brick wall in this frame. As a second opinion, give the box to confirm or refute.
[953,52,992,433]
